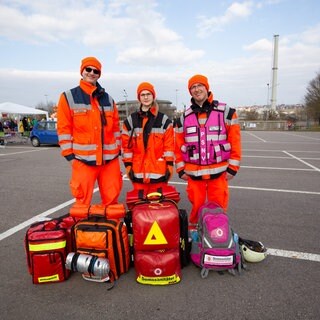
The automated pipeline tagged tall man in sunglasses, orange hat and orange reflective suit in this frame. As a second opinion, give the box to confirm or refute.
[57,57,122,205]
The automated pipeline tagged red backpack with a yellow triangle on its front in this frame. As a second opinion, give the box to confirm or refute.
[132,194,181,285]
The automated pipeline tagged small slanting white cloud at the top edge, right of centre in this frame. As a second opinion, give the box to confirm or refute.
[197,1,254,38]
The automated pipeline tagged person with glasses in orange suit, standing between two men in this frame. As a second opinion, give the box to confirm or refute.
[121,82,174,194]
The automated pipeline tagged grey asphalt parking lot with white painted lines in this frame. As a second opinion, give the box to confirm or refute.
[0,131,320,320]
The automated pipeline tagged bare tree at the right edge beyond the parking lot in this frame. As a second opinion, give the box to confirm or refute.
[304,72,320,125]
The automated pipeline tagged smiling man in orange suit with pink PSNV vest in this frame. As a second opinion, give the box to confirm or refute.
[175,75,241,229]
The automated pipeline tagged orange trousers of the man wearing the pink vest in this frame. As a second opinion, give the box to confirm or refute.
[187,174,229,227]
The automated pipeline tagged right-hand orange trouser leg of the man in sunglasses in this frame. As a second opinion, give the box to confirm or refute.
[98,158,123,205]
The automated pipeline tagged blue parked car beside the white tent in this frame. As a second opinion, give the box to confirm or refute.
[30,121,58,147]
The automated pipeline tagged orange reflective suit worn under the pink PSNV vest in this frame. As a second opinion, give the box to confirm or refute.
[175,93,241,227]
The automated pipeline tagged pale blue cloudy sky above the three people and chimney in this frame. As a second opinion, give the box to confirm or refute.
[0,0,320,109]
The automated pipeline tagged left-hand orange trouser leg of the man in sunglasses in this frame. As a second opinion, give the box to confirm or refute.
[70,160,98,204]
